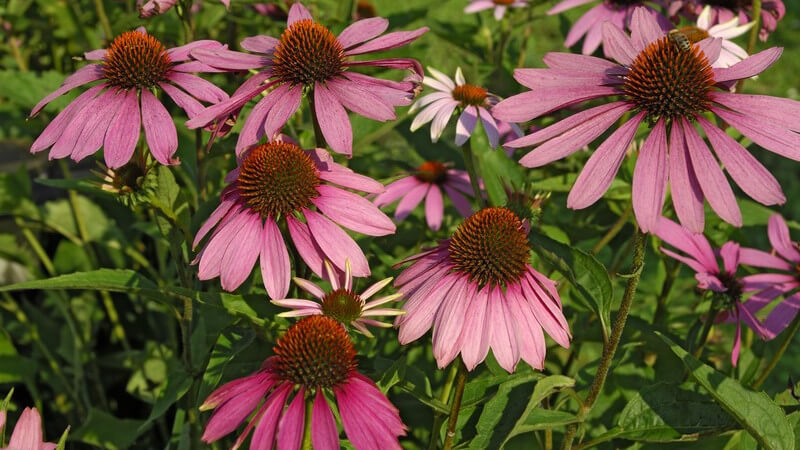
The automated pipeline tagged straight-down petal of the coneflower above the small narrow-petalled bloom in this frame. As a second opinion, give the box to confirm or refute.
[260,218,292,298]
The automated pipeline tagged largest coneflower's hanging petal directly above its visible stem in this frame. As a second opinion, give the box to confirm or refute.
[632,119,667,233]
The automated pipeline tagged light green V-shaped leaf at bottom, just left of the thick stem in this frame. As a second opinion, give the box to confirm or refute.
[503,375,577,443]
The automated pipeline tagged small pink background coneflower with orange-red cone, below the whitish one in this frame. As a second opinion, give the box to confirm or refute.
[374,161,473,231]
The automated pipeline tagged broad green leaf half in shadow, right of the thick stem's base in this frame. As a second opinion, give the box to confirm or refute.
[617,383,736,442]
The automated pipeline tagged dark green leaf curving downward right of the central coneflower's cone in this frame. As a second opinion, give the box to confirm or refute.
[532,234,614,336]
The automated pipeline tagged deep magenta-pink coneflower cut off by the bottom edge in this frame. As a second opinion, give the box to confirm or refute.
[200,316,406,450]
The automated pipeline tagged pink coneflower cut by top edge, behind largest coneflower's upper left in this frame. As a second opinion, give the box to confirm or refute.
[547,0,672,55]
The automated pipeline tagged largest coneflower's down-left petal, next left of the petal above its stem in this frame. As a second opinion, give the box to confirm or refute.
[567,112,644,209]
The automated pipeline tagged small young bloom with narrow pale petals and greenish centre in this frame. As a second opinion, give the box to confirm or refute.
[272,260,405,337]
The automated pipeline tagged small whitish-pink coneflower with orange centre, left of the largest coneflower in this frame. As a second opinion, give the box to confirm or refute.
[409,67,522,148]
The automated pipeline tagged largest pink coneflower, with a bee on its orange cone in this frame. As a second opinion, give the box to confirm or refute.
[493,8,800,232]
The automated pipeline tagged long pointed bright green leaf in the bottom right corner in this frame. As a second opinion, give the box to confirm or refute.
[656,332,794,450]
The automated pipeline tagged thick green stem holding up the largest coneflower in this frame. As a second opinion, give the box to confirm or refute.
[562,230,646,450]
